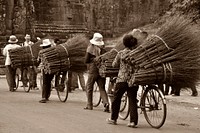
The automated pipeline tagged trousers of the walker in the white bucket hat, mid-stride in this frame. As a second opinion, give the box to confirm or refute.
[86,74,108,107]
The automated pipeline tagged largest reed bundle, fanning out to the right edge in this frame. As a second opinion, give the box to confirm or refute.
[124,17,200,84]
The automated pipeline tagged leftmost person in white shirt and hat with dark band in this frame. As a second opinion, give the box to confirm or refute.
[3,35,20,92]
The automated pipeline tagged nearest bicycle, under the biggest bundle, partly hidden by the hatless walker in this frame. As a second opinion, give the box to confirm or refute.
[119,85,167,128]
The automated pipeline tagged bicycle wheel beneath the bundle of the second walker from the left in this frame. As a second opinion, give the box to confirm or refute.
[55,75,69,102]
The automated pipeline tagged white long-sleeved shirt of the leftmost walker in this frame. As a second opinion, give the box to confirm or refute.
[3,44,21,65]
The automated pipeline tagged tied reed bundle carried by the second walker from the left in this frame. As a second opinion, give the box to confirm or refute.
[40,35,89,74]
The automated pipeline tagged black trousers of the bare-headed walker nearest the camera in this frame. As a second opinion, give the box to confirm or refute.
[111,82,138,125]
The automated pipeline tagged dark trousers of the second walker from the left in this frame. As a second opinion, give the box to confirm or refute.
[42,71,54,99]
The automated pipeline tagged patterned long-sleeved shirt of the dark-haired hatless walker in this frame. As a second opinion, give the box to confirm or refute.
[112,48,132,83]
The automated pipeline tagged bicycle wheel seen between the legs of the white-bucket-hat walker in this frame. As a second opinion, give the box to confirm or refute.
[93,83,101,107]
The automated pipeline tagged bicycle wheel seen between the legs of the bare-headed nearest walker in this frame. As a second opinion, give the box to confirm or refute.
[119,93,130,120]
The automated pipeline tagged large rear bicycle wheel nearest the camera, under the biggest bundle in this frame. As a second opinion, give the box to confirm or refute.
[141,86,167,128]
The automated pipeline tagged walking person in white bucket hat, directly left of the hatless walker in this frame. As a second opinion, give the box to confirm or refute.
[84,33,109,112]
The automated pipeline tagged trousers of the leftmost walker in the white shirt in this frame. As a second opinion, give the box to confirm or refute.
[6,65,16,90]
